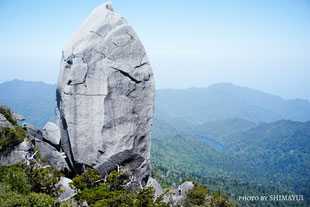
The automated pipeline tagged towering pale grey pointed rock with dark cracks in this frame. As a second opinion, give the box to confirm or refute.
[56,2,154,188]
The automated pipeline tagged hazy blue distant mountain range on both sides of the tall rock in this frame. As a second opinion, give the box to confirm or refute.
[0,80,310,128]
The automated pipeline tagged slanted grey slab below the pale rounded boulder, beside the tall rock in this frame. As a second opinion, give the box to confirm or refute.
[34,139,70,175]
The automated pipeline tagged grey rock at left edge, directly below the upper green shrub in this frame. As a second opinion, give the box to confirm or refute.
[0,139,33,166]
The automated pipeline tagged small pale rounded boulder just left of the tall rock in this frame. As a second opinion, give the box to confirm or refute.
[42,122,60,147]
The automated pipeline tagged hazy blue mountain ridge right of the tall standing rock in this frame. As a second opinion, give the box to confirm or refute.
[155,83,310,124]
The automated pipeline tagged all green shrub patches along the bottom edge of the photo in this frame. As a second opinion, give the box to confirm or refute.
[0,162,239,207]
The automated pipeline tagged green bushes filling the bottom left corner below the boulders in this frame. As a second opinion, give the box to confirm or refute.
[0,163,61,207]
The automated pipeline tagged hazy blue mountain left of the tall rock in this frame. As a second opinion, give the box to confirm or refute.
[0,80,56,129]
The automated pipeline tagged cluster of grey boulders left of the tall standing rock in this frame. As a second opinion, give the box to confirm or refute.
[0,110,71,176]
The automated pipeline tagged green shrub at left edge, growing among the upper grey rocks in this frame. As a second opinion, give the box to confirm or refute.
[0,106,27,152]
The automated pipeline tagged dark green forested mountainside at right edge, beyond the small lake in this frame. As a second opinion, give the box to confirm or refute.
[219,120,310,200]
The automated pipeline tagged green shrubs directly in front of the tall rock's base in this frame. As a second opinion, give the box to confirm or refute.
[71,169,169,207]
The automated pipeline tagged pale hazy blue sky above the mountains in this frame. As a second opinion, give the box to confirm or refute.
[0,0,310,100]
